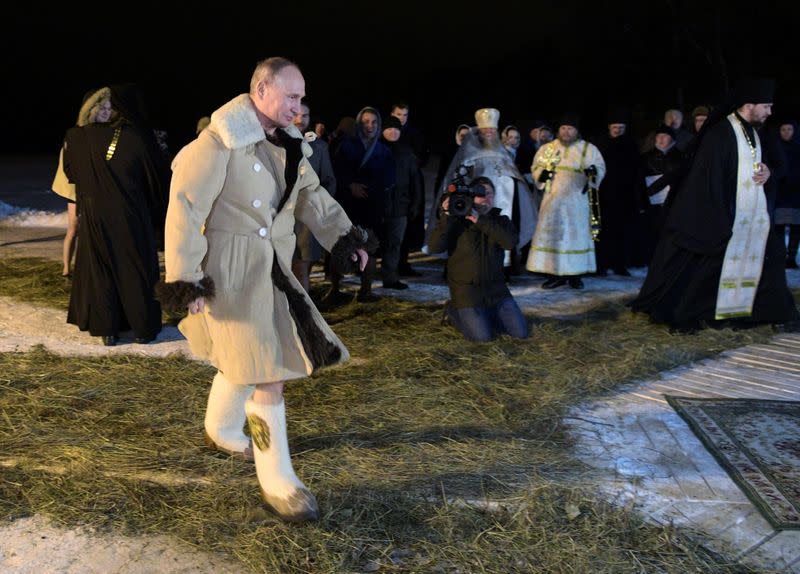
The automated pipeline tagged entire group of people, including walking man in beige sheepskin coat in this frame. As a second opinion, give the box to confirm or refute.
[53,58,800,521]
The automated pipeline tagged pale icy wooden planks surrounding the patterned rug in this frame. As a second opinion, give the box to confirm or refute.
[566,334,800,574]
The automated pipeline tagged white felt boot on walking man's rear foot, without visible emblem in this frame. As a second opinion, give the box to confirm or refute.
[205,371,253,460]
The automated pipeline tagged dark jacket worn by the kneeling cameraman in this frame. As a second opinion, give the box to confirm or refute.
[428,207,519,309]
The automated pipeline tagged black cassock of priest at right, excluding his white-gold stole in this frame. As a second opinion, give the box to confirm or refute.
[630,115,800,329]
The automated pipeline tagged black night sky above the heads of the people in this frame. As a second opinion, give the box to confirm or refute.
[0,0,800,154]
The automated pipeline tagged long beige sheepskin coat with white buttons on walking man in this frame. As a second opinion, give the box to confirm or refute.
[165,94,352,384]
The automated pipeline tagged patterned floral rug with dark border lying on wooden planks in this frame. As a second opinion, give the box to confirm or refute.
[666,396,800,529]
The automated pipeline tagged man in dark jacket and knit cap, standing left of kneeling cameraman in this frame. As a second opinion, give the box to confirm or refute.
[381,116,424,289]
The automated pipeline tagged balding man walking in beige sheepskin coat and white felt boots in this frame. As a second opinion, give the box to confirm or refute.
[159,58,373,521]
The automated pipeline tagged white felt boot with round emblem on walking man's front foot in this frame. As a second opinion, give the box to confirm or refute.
[245,399,319,522]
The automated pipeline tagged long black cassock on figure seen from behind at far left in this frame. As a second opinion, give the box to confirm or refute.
[64,124,167,338]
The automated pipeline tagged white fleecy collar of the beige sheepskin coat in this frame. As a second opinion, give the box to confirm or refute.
[208,94,313,157]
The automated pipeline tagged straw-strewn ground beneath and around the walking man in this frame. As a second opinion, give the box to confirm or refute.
[0,260,770,573]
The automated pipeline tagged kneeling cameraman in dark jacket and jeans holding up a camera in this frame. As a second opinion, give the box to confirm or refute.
[428,177,528,341]
